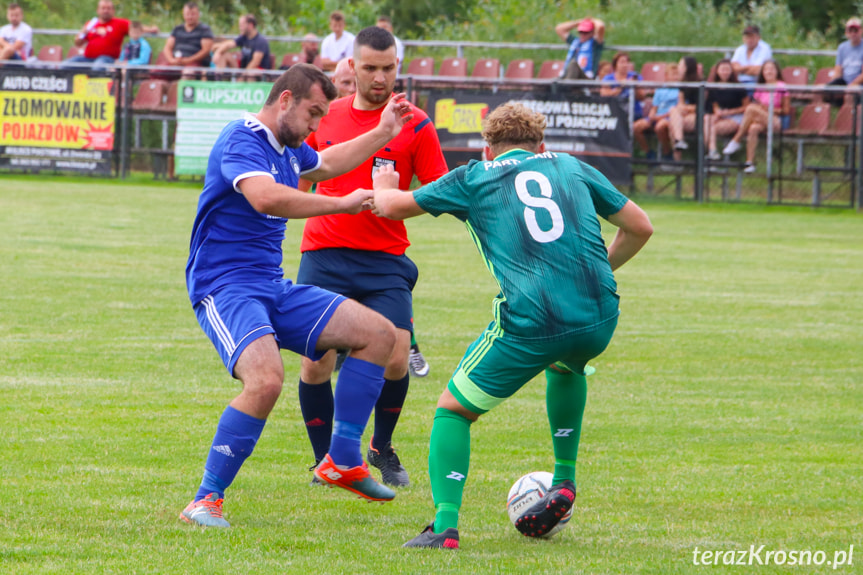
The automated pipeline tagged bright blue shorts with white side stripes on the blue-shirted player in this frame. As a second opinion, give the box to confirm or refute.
[195,279,345,375]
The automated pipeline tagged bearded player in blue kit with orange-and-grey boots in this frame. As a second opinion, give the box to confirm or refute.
[180,64,412,527]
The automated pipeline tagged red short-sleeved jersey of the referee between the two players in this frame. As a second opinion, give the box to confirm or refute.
[300,96,447,255]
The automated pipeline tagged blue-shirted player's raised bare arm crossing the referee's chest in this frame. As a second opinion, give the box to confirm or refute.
[303,94,413,182]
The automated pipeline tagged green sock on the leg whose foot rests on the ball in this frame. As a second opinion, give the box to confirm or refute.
[545,369,587,485]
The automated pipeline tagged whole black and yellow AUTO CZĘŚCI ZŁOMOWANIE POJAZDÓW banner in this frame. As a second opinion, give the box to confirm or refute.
[0,68,115,175]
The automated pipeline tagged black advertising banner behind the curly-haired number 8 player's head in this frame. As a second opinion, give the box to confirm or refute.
[426,89,632,185]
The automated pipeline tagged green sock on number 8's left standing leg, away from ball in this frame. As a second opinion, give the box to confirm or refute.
[429,407,472,533]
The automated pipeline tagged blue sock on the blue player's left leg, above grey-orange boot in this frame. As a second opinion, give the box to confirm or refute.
[195,405,267,501]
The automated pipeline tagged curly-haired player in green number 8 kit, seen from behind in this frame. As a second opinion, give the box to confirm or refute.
[373,103,653,549]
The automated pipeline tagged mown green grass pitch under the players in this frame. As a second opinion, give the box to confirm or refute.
[0,178,863,574]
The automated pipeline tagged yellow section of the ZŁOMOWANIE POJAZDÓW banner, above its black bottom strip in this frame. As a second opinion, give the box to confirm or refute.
[0,69,114,150]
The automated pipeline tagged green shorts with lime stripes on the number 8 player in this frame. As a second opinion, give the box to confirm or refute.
[447,317,617,413]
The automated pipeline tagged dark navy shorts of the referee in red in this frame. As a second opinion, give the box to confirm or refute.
[297,248,419,332]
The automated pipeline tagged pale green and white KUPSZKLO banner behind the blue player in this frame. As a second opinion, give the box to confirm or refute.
[174,80,273,176]
